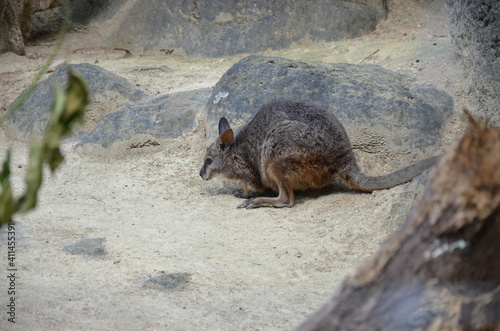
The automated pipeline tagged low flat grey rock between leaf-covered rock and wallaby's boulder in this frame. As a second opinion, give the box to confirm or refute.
[76,89,212,148]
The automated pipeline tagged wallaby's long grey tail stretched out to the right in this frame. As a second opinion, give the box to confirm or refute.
[342,155,442,192]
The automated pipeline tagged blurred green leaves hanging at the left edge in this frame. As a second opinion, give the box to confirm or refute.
[0,71,89,226]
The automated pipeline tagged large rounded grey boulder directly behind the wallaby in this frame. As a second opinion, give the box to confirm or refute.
[206,56,453,167]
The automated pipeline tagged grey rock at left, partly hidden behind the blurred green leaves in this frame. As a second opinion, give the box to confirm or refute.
[8,63,150,138]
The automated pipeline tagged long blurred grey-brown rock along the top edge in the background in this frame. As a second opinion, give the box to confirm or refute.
[63,0,386,57]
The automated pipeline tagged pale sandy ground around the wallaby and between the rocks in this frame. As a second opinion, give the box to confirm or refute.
[0,1,473,330]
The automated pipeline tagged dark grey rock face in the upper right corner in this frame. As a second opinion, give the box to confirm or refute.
[446,0,500,126]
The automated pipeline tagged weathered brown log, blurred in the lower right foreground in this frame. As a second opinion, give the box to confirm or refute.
[297,112,500,331]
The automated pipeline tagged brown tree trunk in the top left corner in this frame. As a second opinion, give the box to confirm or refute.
[0,0,73,55]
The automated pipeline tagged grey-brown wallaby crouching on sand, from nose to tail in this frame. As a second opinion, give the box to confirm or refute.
[200,100,440,208]
